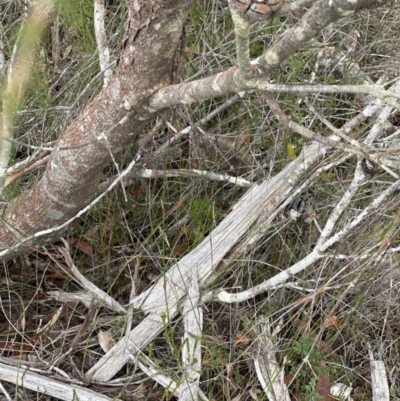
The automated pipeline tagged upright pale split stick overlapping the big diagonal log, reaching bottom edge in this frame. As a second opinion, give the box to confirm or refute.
[179,271,203,401]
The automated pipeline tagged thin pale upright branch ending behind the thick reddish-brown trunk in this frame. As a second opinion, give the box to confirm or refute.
[94,0,112,87]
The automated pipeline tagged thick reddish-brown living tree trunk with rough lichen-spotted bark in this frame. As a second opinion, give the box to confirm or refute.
[0,0,192,249]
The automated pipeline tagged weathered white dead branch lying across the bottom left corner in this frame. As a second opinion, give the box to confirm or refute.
[0,363,114,401]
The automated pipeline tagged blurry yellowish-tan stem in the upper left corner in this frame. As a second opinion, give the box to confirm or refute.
[0,0,53,194]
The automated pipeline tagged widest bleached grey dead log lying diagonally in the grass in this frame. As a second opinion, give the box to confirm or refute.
[87,138,332,381]
